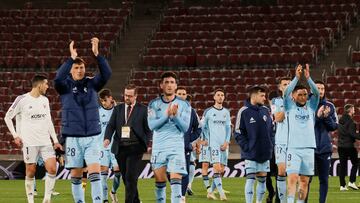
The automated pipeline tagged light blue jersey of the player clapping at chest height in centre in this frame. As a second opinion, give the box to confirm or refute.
[148,96,191,152]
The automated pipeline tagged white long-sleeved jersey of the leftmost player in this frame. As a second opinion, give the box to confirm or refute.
[4,93,58,147]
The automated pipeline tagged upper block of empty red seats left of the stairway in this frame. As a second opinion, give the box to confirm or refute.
[0,1,133,71]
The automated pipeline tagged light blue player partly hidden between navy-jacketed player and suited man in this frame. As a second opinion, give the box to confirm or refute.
[99,89,121,202]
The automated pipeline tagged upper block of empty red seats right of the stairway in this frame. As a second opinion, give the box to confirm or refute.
[142,0,359,67]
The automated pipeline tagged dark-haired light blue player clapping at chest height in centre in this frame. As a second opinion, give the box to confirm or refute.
[148,72,191,203]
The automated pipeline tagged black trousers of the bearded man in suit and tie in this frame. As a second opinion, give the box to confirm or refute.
[115,148,143,203]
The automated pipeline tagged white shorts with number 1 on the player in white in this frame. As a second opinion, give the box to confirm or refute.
[22,145,55,164]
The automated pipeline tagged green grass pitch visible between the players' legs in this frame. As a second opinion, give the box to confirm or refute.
[0,177,360,203]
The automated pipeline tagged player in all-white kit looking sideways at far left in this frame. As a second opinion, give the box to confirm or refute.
[4,75,62,203]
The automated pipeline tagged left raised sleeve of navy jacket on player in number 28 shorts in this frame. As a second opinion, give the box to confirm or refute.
[54,58,74,94]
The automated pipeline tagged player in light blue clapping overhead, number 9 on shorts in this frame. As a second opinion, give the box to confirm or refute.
[284,64,320,203]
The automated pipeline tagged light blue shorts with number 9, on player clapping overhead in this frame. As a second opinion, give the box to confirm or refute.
[286,148,315,176]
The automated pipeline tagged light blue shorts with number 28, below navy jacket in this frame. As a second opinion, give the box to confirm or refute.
[65,136,101,168]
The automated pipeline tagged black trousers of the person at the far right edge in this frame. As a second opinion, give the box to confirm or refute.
[338,147,358,187]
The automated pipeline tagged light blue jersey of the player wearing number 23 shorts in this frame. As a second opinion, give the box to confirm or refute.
[202,106,231,147]
